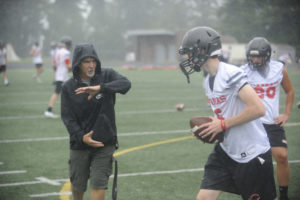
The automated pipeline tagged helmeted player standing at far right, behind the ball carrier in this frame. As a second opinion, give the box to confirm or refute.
[241,37,294,200]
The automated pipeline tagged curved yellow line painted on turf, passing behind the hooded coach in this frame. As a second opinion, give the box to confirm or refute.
[59,136,193,200]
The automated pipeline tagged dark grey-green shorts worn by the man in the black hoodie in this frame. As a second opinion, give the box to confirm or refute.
[69,145,115,192]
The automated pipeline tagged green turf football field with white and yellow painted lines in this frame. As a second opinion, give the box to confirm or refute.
[0,65,300,200]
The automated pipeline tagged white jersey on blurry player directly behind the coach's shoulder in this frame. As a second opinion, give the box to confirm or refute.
[55,48,70,81]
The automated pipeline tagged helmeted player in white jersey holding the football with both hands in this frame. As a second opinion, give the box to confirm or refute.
[179,27,276,200]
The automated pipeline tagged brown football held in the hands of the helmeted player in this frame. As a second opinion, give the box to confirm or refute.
[190,116,224,144]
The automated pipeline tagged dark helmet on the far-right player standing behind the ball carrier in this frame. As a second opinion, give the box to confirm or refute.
[246,37,272,70]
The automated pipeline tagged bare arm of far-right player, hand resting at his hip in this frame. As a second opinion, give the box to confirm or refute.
[274,69,295,126]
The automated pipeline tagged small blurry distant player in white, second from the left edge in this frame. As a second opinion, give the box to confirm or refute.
[29,42,44,83]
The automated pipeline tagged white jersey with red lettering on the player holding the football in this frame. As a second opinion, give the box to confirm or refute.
[205,62,270,163]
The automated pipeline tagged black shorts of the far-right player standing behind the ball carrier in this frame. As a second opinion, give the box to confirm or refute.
[264,124,287,148]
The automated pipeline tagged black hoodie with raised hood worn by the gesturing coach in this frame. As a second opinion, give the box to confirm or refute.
[61,44,131,150]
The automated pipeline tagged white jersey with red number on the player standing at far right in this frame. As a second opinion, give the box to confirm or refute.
[241,60,284,124]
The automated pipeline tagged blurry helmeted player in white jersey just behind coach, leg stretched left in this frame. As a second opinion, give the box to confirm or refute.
[44,38,72,118]
